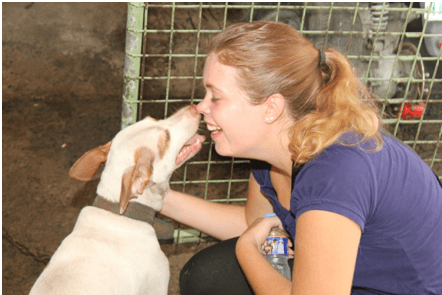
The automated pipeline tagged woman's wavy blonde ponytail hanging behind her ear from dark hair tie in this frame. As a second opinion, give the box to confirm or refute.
[289,49,383,164]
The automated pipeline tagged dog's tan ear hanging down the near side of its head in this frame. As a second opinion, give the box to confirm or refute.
[120,146,155,214]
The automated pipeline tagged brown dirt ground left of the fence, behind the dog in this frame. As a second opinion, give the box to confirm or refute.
[2,3,218,295]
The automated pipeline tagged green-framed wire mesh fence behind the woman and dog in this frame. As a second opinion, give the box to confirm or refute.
[122,2,442,243]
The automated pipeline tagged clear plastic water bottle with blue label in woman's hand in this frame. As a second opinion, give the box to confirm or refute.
[261,213,292,281]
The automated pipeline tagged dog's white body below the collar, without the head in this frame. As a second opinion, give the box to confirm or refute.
[31,207,169,295]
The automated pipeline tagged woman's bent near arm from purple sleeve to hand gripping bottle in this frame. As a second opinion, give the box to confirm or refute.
[236,210,361,295]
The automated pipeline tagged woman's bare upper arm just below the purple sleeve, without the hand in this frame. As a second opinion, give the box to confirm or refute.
[292,210,362,295]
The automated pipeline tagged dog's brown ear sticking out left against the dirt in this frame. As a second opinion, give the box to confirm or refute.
[69,141,112,181]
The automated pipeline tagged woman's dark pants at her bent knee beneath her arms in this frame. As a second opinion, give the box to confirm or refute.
[180,238,394,295]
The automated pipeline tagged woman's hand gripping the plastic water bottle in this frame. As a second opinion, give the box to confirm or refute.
[237,216,293,258]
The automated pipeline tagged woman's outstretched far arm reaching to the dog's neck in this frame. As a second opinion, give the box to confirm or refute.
[160,175,273,240]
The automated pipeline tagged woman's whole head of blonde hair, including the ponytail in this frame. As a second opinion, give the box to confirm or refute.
[209,21,383,164]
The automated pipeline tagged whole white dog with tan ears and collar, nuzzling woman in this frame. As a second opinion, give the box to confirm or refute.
[30,106,204,295]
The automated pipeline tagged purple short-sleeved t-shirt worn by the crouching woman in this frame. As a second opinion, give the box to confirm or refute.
[252,134,442,294]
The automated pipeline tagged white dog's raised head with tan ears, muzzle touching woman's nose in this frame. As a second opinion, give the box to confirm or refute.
[69,105,205,214]
